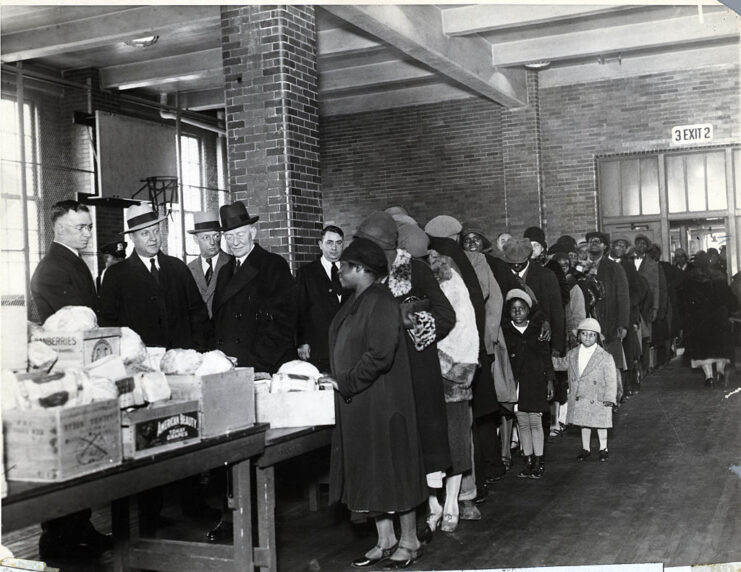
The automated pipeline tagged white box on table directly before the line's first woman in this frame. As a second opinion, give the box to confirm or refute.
[255,389,334,429]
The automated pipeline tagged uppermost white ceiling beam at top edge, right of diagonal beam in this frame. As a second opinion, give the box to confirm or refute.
[441,4,625,36]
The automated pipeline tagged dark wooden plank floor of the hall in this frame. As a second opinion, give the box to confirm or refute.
[3,359,741,572]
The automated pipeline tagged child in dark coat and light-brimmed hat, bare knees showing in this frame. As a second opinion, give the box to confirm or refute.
[502,288,554,479]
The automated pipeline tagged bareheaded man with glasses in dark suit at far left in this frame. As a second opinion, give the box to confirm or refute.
[31,200,113,560]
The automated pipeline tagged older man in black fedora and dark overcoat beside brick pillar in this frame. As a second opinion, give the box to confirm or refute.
[206,201,296,542]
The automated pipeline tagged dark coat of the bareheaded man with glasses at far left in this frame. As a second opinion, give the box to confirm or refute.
[31,242,98,323]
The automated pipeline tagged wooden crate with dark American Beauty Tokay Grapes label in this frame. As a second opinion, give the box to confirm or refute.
[121,401,201,459]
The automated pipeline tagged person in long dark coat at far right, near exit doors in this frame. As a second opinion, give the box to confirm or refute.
[682,250,736,385]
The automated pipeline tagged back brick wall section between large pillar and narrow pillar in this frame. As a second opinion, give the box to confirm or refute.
[321,98,505,236]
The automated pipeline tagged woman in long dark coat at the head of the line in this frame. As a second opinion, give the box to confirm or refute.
[322,238,427,568]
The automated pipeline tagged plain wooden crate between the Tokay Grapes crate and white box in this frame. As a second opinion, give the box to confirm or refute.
[167,367,255,439]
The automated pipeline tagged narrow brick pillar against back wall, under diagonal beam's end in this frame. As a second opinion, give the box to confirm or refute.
[502,71,545,237]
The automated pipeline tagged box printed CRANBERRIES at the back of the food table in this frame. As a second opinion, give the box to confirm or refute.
[31,328,121,371]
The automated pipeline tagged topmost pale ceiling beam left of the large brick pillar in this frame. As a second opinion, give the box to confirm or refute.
[2,5,221,62]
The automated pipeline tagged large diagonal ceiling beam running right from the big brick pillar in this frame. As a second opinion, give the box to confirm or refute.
[323,4,527,107]
